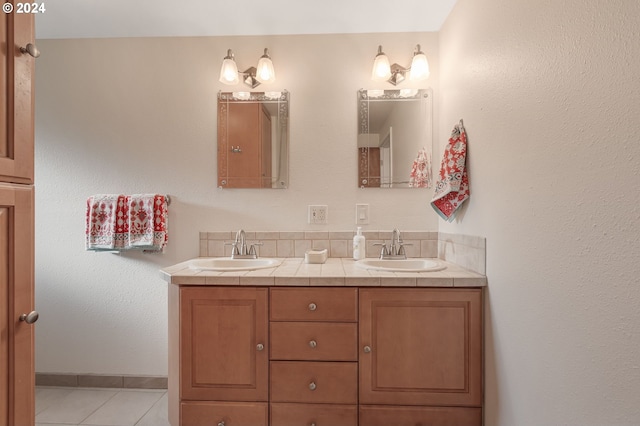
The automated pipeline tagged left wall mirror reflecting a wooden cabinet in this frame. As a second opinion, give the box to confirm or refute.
[218,91,289,188]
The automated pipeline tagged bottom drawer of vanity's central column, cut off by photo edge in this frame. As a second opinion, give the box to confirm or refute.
[271,403,358,426]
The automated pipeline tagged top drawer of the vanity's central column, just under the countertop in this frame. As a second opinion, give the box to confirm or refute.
[271,287,358,322]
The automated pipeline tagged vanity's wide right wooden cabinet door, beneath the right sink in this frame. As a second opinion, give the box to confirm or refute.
[359,289,482,406]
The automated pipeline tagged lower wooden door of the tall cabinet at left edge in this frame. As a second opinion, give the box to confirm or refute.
[0,183,35,426]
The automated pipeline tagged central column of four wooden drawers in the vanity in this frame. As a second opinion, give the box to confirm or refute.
[270,288,358,426]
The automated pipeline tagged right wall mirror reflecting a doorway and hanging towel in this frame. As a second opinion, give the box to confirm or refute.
[358,89,433,188]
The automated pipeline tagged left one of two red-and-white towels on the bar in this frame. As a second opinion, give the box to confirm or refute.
[85,194,127,250]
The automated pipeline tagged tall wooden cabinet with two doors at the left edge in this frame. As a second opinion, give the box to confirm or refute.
[0,7,37,426]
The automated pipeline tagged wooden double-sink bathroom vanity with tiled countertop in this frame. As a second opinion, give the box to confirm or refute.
[162,258,486,426]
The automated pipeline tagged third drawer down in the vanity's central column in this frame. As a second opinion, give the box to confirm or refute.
[271,361,358,404]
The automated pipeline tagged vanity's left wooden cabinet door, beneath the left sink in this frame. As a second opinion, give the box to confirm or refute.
[180,287,269,401]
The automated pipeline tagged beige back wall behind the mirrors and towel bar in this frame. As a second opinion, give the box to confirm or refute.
[36,33,438,375]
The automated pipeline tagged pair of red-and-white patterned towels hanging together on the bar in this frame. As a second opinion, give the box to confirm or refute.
[85,194,168,251]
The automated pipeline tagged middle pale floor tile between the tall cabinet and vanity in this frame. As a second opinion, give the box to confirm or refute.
[36,389,117,425]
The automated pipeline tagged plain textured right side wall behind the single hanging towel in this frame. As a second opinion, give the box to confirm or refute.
[439,0,640,426]
